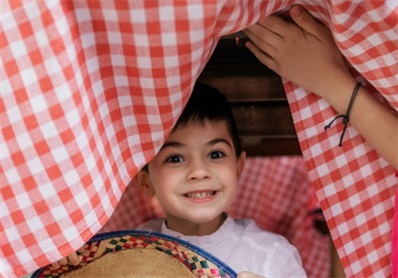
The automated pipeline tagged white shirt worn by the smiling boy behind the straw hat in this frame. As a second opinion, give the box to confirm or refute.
[136,216,307,278]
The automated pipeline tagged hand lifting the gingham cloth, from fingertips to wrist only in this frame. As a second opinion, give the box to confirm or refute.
[244,5,355,99]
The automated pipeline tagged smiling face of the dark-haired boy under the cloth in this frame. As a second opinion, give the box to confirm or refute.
[140,122,245,232]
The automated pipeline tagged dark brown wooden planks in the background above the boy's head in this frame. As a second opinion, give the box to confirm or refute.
[199,33,301,156]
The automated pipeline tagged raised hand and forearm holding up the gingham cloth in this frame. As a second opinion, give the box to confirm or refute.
[244,5,398,169]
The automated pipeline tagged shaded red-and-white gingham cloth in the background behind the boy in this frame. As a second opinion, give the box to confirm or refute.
[100,156,331,278]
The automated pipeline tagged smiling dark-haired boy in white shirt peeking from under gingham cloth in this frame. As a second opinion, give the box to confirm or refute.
[137,83,306,277]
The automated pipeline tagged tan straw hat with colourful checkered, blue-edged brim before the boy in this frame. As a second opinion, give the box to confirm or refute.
[32,231,236,278]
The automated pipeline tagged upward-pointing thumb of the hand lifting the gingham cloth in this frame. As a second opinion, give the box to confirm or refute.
[290,5,327,40]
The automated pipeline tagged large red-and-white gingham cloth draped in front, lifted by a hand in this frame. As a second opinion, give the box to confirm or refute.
[0,0,398,277]
